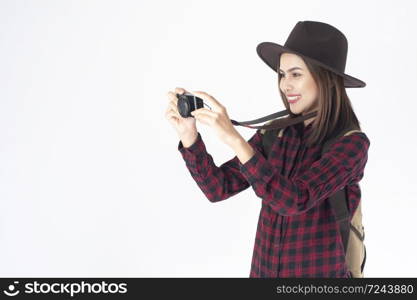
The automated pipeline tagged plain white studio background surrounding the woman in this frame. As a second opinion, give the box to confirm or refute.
[0,0,417,277]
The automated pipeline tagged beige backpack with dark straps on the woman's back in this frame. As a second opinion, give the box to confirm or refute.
[261,121,366,278]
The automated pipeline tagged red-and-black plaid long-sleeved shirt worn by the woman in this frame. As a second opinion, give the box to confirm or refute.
[178,123,370,277]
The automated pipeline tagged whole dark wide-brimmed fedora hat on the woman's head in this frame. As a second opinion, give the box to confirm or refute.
[256,21,366,88]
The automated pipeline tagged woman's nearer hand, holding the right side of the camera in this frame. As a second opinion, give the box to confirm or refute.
[191,91,243,147]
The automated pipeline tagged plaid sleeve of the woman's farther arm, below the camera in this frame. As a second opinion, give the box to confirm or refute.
[178,130,262,202]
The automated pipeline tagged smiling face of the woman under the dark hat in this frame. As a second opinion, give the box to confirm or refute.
[278,53,318,114]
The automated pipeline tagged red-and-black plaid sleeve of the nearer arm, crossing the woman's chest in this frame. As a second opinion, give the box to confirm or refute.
[241,133,370,215]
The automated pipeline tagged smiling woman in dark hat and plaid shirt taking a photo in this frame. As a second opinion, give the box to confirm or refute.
[166,21,370,277]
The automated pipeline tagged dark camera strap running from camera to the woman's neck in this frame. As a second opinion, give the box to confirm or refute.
[230,109,317,130]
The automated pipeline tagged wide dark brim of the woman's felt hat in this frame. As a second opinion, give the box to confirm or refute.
[256,42,366,88]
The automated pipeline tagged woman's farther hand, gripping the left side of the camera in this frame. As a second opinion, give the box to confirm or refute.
[165,88,198,147]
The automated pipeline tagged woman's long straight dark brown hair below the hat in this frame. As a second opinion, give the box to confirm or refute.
[278,57,361,146]
